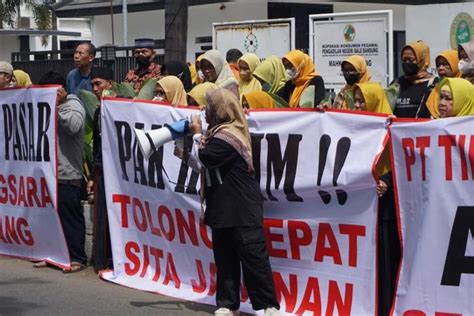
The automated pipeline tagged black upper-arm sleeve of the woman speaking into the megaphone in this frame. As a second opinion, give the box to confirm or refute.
[199,138,239,169]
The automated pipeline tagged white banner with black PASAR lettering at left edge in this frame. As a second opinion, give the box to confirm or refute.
[0,86,69,267]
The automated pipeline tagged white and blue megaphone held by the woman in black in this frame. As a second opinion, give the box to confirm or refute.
[135,119,189,159]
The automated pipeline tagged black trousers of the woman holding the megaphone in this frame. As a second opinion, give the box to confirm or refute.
[212,227,280,310]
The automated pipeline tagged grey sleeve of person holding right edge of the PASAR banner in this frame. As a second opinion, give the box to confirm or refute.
[58,100,86,135]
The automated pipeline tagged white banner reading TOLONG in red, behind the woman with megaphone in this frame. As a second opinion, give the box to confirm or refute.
[102,99,386,315]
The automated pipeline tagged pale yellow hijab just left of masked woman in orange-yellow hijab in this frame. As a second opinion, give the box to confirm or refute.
[253,56,287,94]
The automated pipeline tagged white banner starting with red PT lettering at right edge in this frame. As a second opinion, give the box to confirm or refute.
[391,117,474,316]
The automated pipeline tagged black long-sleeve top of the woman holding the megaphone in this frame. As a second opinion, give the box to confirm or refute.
[199,138,263,229]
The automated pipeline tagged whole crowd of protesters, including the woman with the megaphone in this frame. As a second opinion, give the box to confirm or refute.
[0,33,474,315]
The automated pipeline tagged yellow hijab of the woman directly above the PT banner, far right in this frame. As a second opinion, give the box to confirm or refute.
[439,78,474,117]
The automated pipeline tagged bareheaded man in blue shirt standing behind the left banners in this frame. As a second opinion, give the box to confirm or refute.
[66,43,96,95]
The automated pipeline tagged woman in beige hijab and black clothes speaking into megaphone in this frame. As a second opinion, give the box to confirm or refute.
[182,88,279,315]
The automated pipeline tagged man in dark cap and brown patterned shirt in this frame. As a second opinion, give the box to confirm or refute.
[124,38,161,91]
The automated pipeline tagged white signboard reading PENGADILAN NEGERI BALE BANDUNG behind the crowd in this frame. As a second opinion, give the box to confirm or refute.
[312,19,388,90]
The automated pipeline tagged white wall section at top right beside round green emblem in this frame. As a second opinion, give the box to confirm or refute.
[406,2,474,73]
